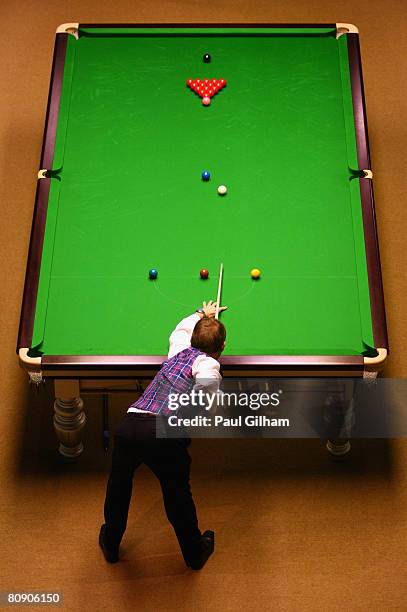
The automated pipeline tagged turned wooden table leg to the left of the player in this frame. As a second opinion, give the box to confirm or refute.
[54,380,86,458]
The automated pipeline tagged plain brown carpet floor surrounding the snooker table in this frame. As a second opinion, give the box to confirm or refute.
[0,0,407,612]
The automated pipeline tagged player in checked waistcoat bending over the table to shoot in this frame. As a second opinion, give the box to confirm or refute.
[99,300,226,570]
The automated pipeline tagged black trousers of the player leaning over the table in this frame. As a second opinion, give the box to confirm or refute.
[104,412,201,563]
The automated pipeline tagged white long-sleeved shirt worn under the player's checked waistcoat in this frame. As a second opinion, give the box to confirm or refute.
[128,312,222,413]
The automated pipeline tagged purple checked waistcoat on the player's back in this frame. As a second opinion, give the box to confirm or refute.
[130,346,205,416]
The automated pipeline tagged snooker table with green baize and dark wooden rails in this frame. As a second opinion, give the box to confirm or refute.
[17,23,388,456]
